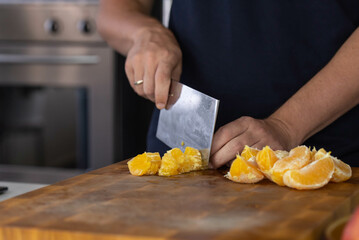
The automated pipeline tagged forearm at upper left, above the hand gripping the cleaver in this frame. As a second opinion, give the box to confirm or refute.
[97,0,163,55]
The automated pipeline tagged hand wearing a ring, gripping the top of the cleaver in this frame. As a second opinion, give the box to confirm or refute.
[125,26,182,109]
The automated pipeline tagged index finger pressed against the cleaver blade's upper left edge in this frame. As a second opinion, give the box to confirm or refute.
[155,63,172,109]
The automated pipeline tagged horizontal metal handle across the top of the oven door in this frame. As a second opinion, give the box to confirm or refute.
[0,54,100,64]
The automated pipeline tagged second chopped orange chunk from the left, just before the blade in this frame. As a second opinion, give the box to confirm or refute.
[158,148,185,176]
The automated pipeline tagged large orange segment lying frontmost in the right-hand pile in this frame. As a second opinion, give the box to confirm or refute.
[283,154,334,190]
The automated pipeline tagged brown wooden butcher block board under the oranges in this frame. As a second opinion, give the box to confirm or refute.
[0,162,359,240]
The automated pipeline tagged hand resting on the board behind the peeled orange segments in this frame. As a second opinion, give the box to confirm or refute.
[210,117,297,168]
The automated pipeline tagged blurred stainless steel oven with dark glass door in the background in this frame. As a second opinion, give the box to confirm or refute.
[0,0,115,183]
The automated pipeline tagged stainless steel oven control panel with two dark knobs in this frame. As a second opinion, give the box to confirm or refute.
[0,0,103,42]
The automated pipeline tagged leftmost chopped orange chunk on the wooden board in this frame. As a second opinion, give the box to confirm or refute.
[127,152,161,176]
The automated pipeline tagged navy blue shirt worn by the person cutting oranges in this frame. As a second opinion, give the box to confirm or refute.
[147,0,359,166]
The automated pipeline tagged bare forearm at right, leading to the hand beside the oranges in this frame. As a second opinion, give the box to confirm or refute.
[269,29,359,147]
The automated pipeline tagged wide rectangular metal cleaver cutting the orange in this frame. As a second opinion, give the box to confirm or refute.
[156,81,219,165]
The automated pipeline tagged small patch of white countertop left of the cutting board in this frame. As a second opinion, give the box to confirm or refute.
[0,181,47,202]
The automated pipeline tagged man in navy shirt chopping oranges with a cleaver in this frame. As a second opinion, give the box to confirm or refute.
[98,0,359,168]
